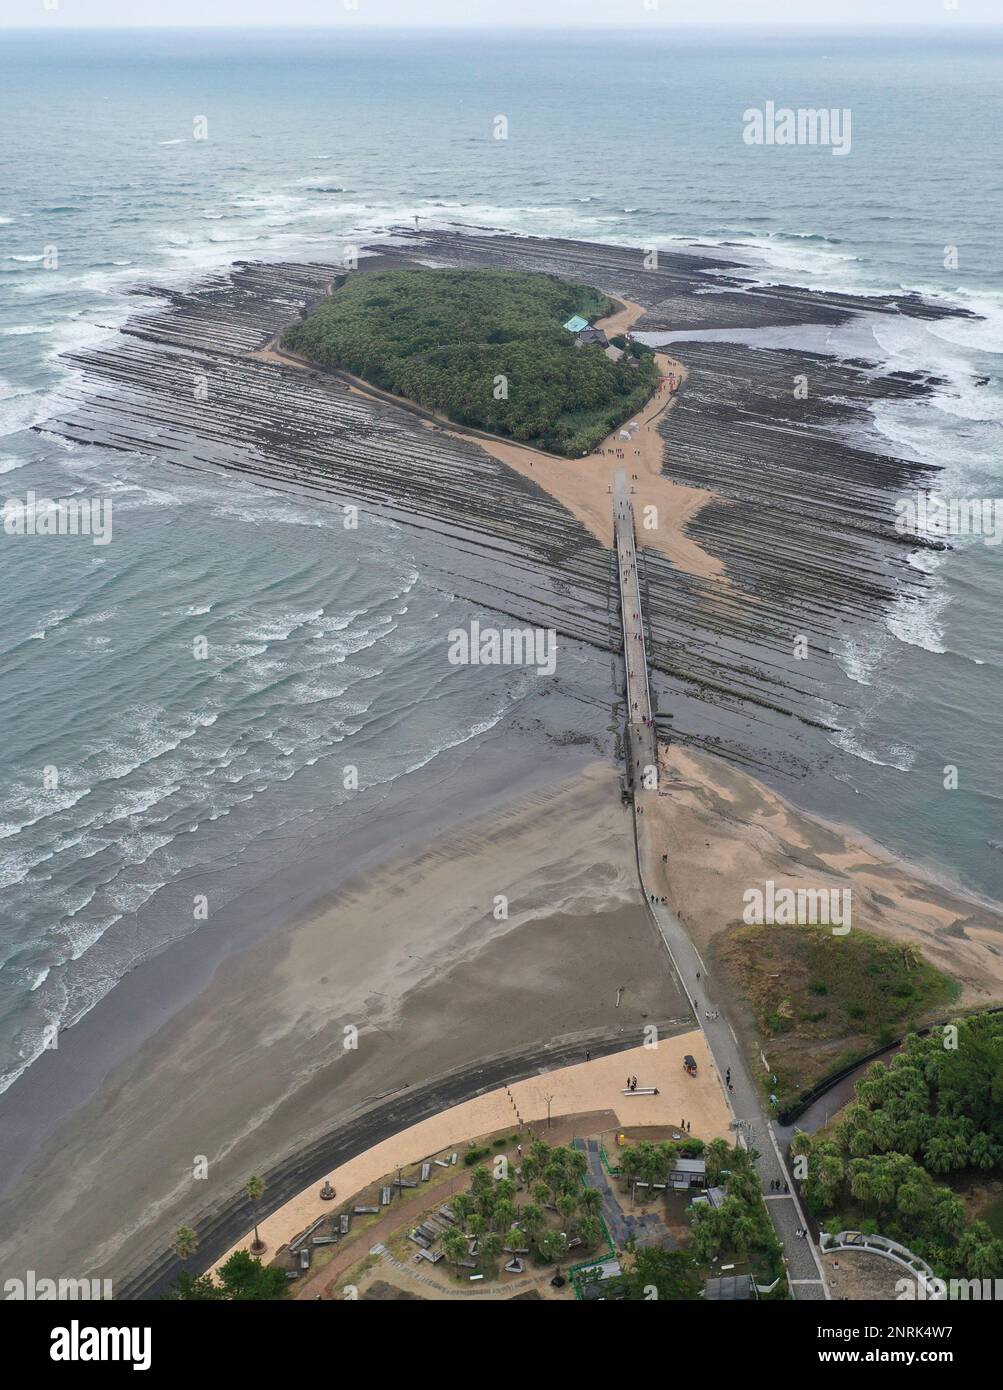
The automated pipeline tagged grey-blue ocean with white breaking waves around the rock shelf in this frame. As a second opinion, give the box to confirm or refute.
[0,31,1003,1084]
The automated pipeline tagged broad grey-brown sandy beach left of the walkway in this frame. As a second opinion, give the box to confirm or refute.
[0,765,692,1277]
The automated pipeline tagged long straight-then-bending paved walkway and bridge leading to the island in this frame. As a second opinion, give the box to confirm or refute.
[613,471,828,1298]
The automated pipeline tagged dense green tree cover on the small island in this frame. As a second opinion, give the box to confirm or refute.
[282,270,658,457]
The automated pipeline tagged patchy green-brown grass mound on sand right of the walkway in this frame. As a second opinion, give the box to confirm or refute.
[718,926,957,1104]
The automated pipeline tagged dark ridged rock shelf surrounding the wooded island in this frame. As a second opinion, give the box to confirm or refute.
[46,231,966,771]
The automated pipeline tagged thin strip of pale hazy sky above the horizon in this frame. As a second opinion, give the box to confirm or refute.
[0,0,1002,28]
